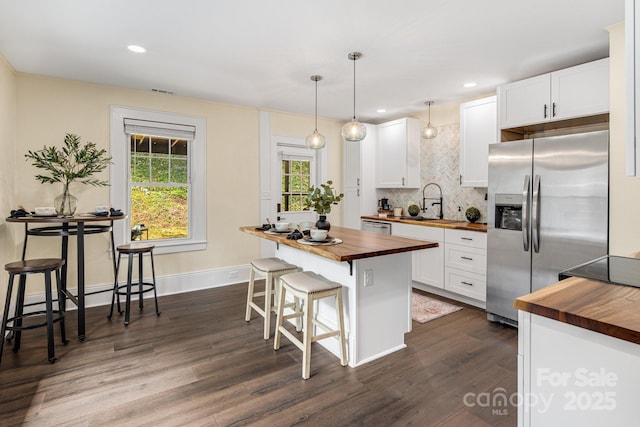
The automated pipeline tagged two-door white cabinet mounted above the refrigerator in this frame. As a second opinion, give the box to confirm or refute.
[498,58,609,129]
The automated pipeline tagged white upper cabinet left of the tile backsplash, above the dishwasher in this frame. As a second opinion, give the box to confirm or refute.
[376,118,420,188]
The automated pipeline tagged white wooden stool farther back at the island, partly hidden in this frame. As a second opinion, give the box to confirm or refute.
[244,258,300,340]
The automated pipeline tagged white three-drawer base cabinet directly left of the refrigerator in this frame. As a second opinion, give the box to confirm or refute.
[444,229,487,302]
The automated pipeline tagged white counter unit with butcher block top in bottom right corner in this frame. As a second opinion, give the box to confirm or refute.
[512,277,640,427]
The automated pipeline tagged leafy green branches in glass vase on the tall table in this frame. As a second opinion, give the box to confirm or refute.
[24,133,111,216]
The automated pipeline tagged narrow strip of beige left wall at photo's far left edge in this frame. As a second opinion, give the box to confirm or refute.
[0,55,18,307]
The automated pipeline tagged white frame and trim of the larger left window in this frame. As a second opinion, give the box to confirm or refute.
[109,105,207,253]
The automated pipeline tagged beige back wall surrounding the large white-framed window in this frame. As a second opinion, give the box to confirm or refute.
[7,74,342,292]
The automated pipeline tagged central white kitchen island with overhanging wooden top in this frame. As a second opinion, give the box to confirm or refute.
[240,226,438,367]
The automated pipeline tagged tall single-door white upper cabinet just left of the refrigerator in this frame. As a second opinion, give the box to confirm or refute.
[460,96,498,187]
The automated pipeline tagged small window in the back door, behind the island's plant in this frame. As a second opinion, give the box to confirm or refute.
[281,158,311,212]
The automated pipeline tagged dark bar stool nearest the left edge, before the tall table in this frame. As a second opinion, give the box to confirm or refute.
[0,258,68,363]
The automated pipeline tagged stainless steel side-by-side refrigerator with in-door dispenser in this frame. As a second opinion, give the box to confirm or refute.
[487,131,609,324]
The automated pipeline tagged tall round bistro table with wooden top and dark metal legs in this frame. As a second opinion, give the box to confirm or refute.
[6,214,125,341]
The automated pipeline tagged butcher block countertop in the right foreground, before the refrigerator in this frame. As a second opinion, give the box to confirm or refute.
[513,277,640,344]
